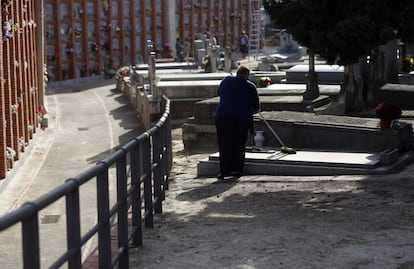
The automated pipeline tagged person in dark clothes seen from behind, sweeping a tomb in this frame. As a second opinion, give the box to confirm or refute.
[215,66,260,179]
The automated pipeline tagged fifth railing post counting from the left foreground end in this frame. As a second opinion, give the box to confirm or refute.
[130,142,142,246]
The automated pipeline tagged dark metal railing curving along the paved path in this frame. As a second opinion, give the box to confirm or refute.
[0,96,172,269]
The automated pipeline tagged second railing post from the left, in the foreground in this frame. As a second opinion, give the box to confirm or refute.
[66,178,82,269]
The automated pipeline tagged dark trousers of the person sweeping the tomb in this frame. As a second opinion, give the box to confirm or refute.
[215,117,251,174]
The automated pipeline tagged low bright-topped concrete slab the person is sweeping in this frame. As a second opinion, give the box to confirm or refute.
[197,150,413,177]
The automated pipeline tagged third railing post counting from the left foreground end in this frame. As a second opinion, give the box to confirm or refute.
[96,168,112,268]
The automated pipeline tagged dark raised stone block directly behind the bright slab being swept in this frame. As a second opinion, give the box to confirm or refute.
[254,111,413,152]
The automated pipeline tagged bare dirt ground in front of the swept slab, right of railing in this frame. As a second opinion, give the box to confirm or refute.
[130,128,414,269]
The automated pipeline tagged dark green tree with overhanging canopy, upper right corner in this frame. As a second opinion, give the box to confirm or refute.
[264,0,414,112]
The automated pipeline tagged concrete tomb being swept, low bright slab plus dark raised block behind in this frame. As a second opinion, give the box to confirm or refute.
[198,111,413,176]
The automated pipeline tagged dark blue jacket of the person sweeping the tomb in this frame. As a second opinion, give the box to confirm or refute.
[215,76,260,121]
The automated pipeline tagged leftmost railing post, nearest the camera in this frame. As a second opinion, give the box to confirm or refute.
[22,203,40,269]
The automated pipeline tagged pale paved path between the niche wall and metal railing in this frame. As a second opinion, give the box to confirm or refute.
[0,77,142,268]
